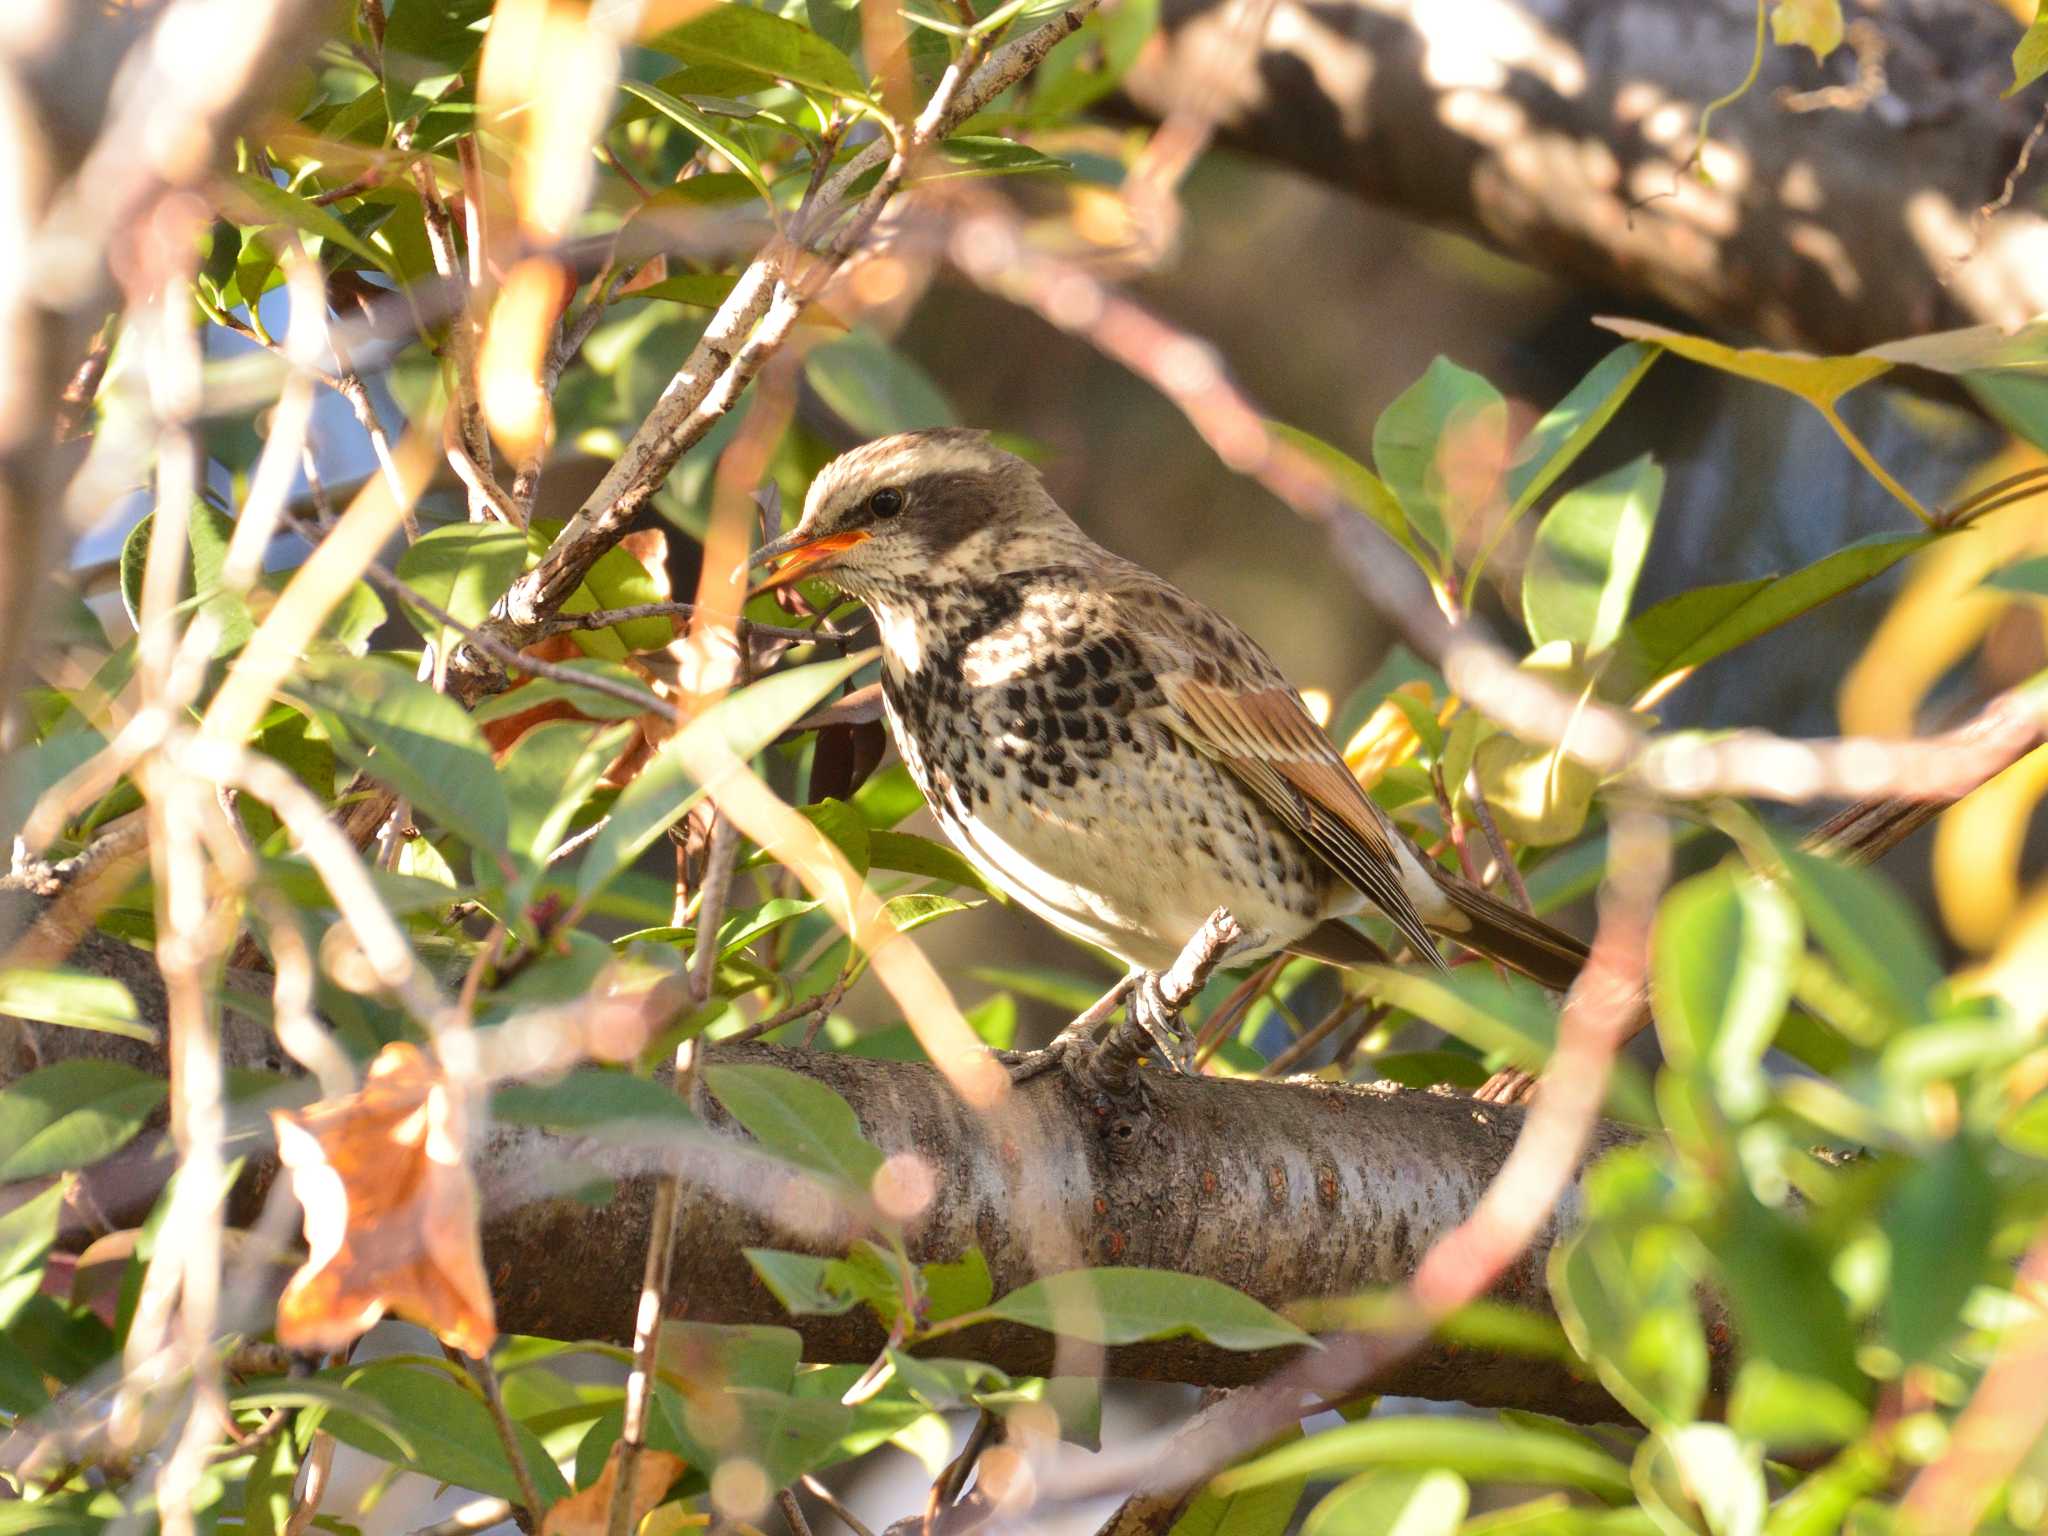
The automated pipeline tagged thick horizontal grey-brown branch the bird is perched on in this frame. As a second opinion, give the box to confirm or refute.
[0,889,1628,1421]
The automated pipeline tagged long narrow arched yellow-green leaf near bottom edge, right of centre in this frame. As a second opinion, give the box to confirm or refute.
[1210,1417,1632,1503]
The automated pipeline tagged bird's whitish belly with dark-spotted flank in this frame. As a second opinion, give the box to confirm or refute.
[899,704,1335,969]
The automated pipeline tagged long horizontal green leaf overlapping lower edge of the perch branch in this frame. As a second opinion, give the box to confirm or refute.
[987,1270,1313,1350]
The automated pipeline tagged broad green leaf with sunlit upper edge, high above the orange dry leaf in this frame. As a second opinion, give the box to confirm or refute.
[289,655,510,858]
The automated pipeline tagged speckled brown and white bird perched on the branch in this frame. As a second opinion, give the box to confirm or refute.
[750,428,1587,1065]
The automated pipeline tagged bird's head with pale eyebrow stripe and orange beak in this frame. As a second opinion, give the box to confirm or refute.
[752,428,1079,602]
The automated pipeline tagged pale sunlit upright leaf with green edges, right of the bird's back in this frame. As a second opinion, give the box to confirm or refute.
[1522,455,1663,655]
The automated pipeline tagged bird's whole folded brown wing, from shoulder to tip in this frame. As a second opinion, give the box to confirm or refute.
[1110,567,1444,965]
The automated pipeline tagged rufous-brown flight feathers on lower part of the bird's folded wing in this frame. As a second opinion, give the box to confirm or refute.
[1159,674,1444,965]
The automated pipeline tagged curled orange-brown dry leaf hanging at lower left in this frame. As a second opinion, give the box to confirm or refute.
[270,1042,498,1358]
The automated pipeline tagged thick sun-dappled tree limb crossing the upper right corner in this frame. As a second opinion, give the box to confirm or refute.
[1124,0,2048,352]
